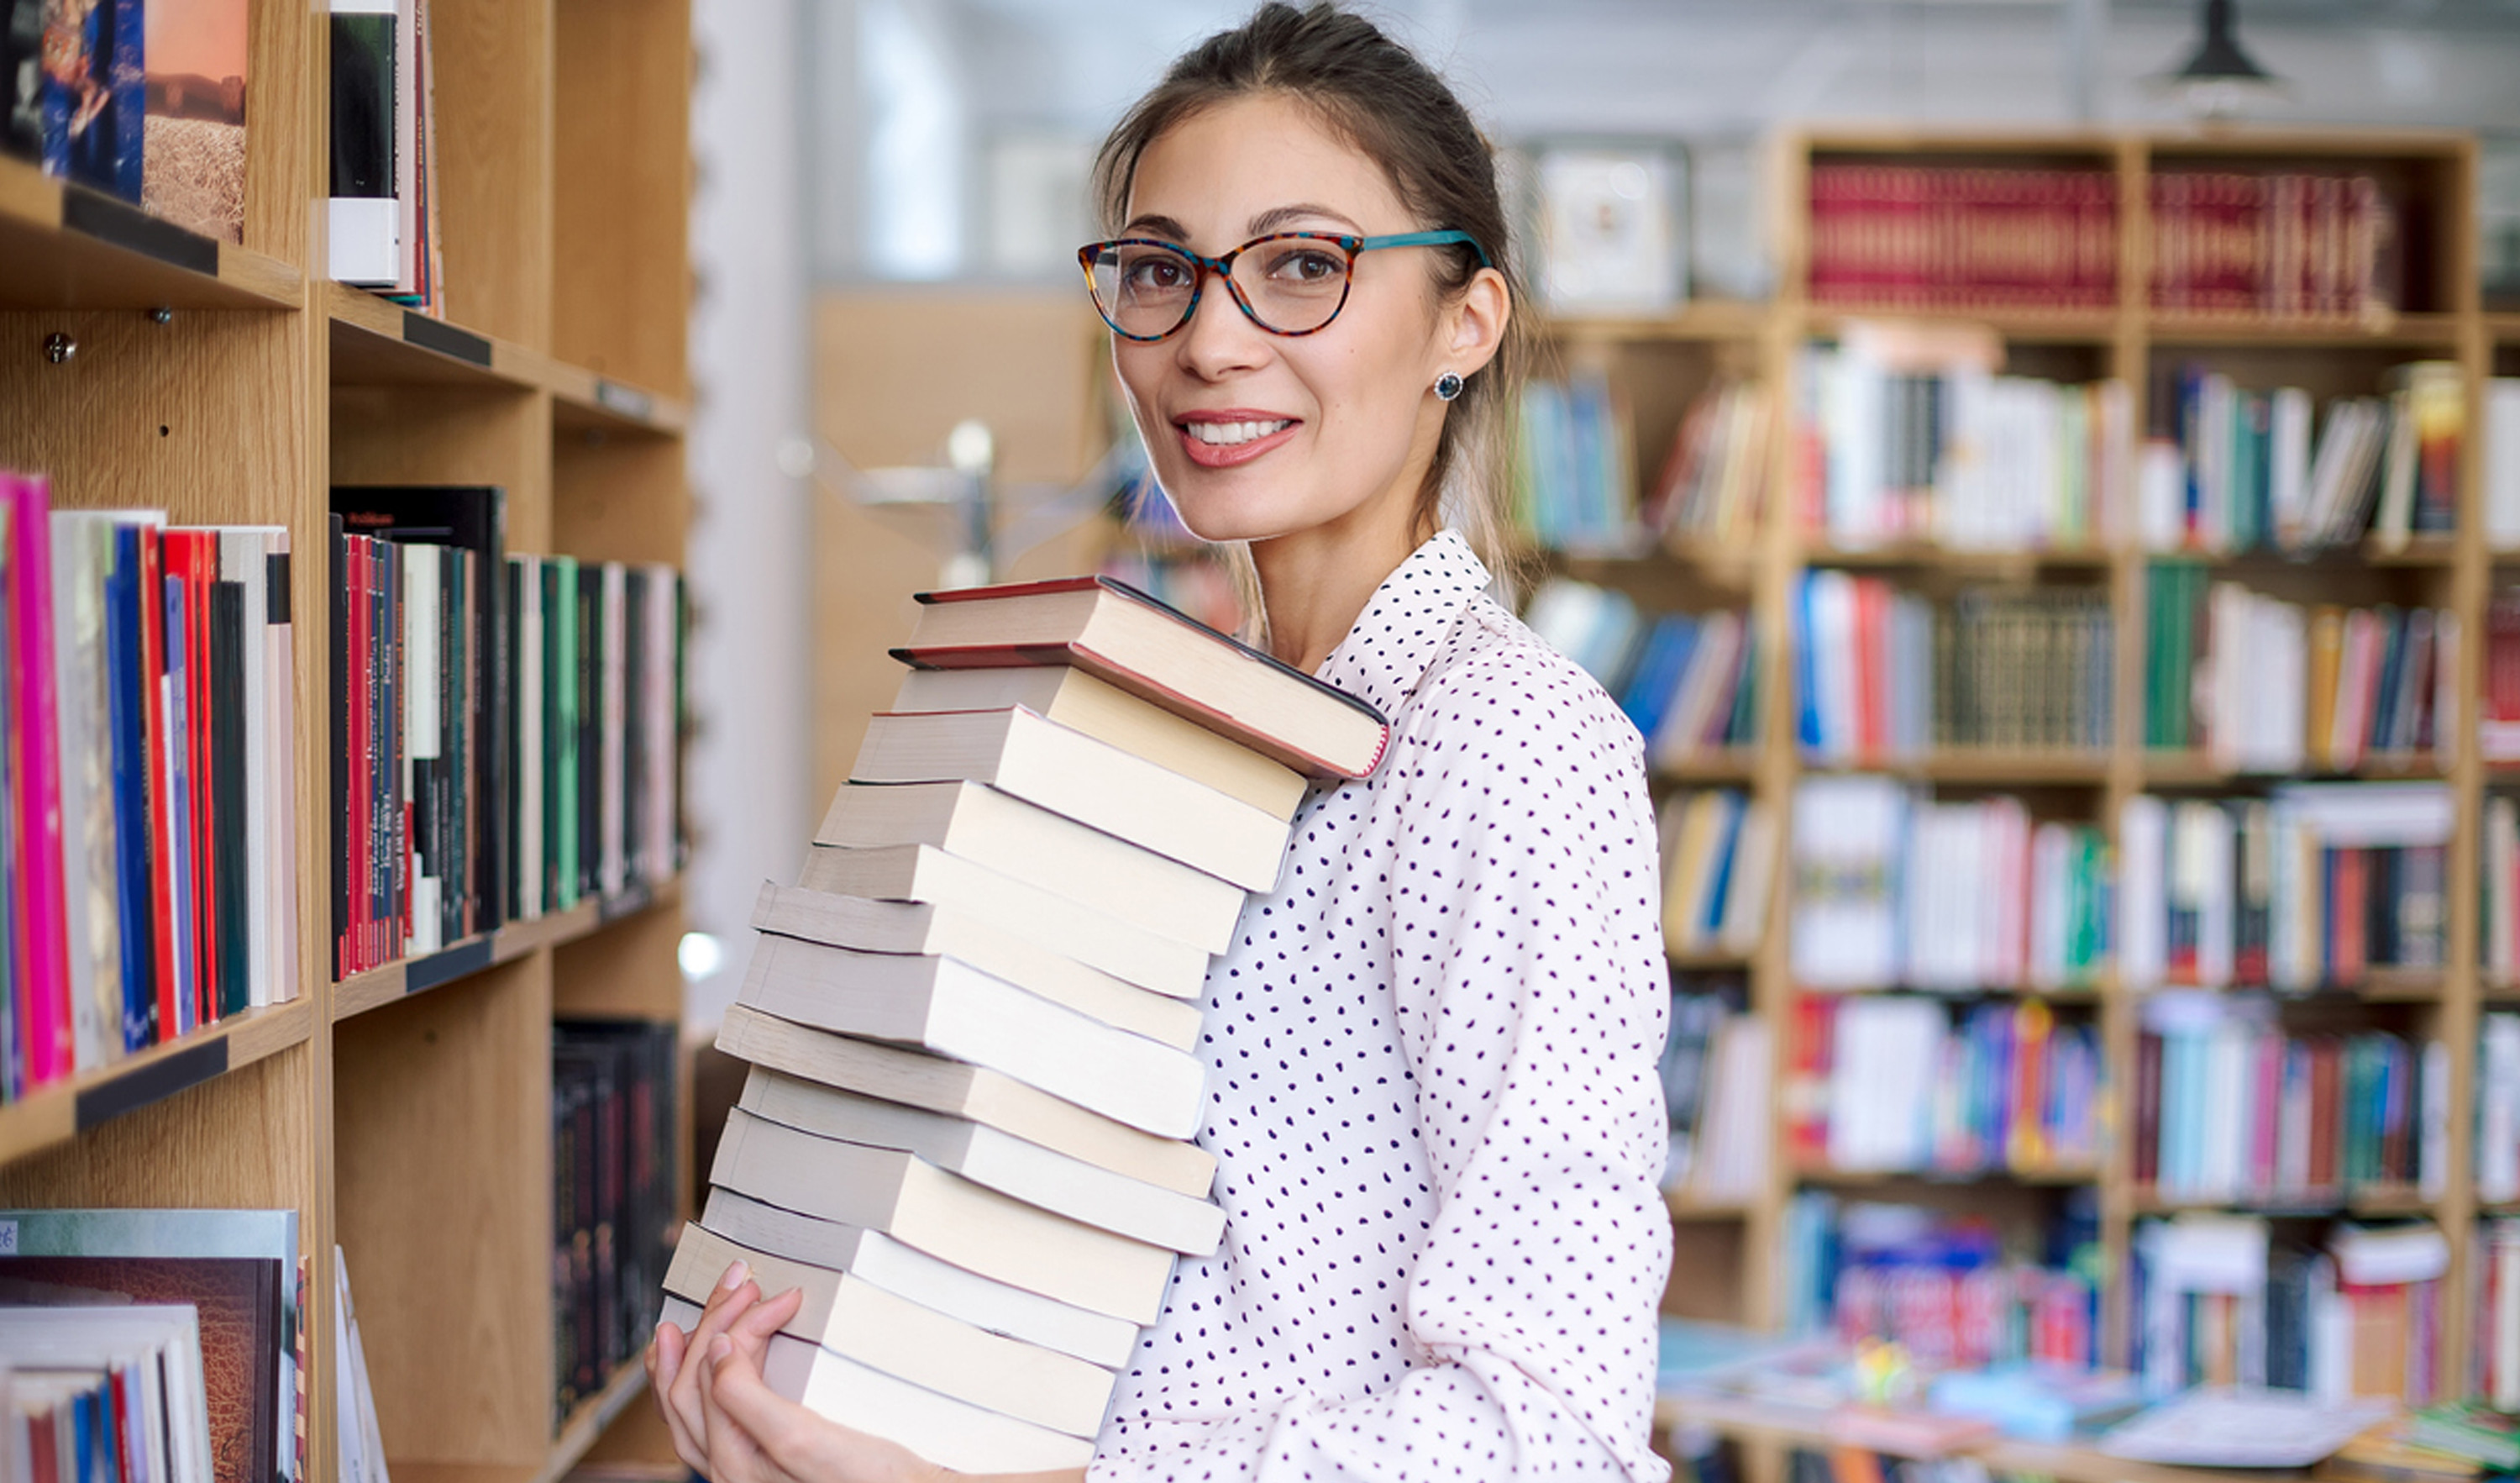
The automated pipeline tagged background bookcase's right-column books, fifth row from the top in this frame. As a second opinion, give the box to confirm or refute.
[2129,991,2449,1206]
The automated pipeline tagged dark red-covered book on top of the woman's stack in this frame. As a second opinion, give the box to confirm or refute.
[892,577,1391,780]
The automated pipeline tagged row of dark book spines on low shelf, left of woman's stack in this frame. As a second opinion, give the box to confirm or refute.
[552,1022,680,1428]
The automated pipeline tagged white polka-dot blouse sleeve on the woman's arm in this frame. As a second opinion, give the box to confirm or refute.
[1091,643,1671,1483]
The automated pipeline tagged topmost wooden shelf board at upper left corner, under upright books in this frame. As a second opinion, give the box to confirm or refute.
[0,156,305,310]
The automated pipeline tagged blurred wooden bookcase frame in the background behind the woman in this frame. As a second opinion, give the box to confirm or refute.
[1547,129,2490,1480]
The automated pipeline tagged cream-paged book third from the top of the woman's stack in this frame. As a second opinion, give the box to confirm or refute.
[849,706,1288,893]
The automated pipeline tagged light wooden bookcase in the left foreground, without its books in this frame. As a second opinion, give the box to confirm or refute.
[0,0,693,1483]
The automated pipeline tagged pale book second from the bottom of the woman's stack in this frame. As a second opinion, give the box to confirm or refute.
[665,1226,1114,1438]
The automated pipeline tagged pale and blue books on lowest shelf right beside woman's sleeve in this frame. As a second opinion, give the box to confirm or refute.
[1663,976,1772,1206]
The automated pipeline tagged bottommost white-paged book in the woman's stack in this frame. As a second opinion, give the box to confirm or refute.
[665,1296,1094,1473]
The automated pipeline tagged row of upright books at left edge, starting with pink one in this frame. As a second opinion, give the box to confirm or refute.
[0,474,297,1100]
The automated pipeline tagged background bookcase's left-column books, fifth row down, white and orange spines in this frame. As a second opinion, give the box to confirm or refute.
[1784,994,2102,1178]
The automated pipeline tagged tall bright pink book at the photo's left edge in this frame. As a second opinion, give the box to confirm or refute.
[0,474,71,1087]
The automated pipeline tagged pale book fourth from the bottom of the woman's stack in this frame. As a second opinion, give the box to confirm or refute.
[708,1107,1172,1324]
